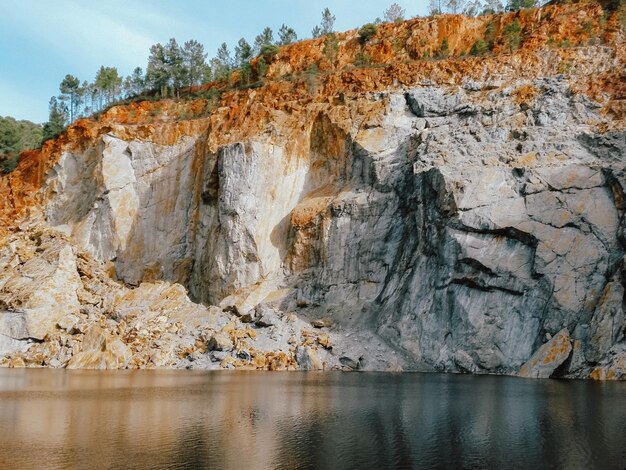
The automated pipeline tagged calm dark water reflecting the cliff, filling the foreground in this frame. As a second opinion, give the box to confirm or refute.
[0,369,626,470]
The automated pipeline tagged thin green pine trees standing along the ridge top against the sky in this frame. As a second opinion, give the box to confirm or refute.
[43,0,542,141]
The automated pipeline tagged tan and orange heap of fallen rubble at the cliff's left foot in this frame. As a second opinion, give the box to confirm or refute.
[0,227,360,370]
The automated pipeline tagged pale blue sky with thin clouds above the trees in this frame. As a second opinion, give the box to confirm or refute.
[0,0,427,122]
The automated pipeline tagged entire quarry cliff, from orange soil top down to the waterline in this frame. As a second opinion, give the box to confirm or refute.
[0,2,626,379]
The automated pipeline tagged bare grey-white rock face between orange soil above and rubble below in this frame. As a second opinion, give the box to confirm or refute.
[30,77,626,376]
